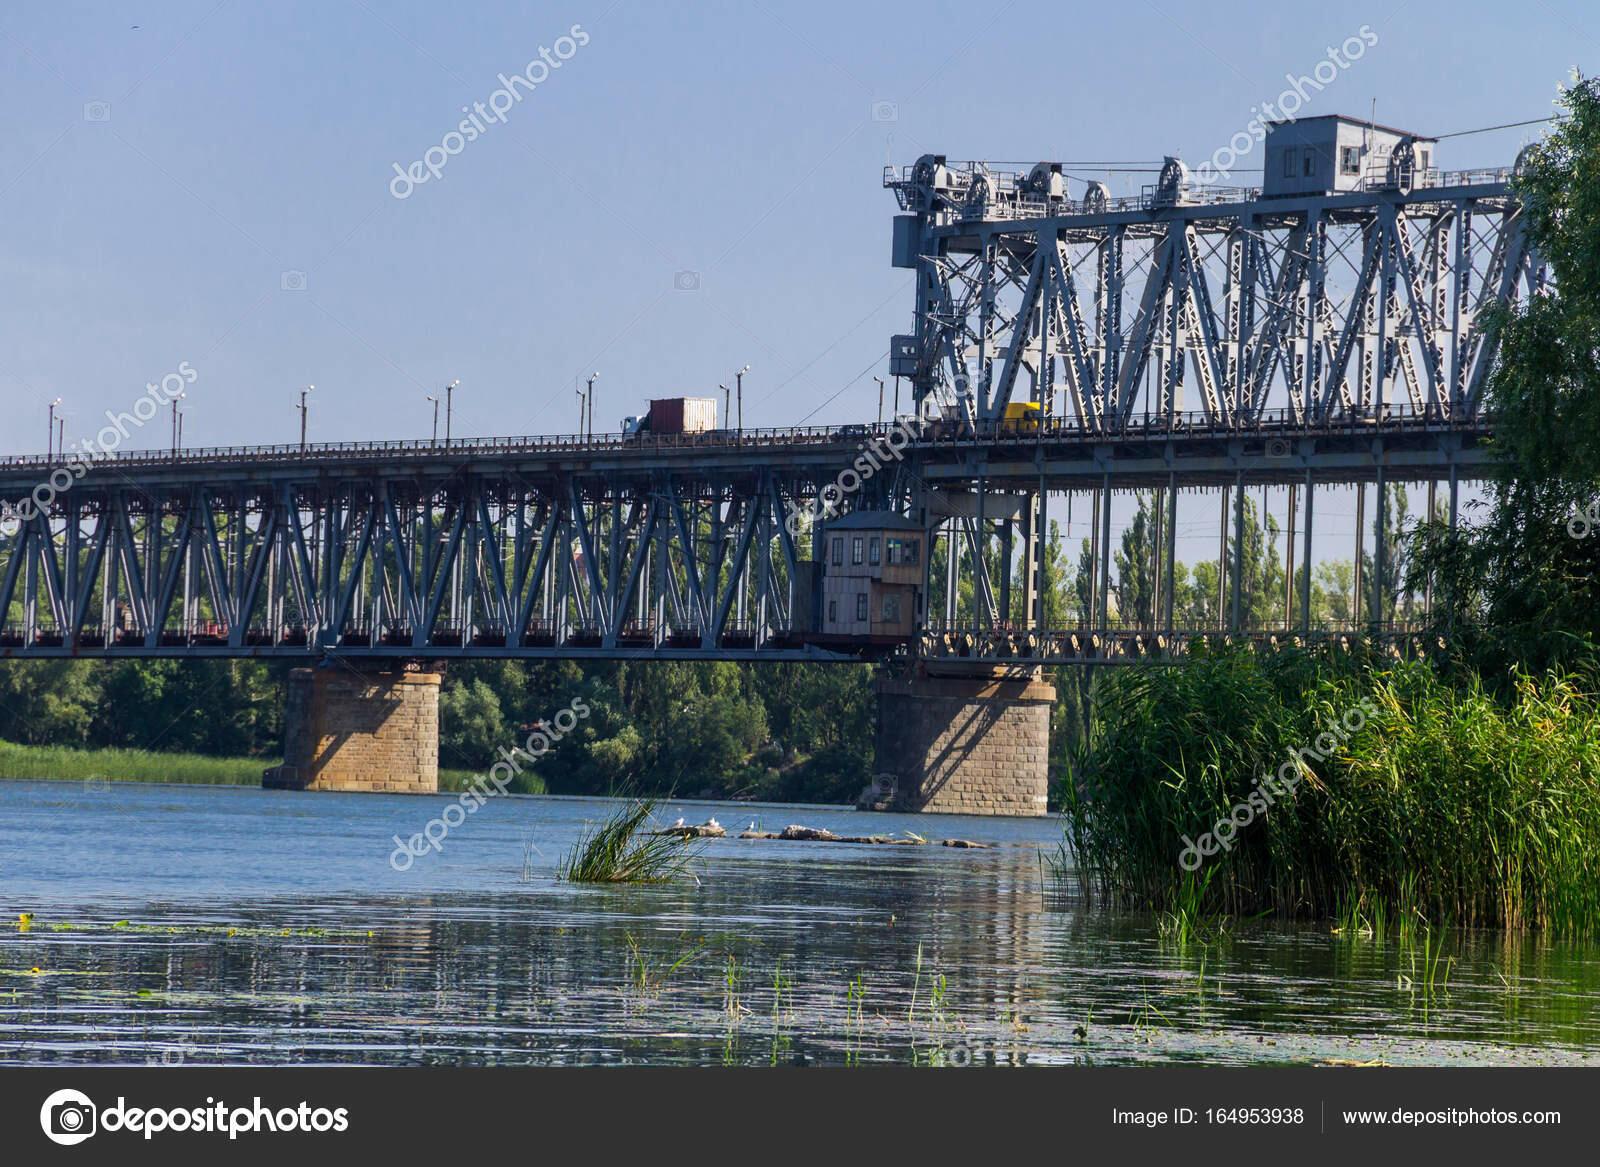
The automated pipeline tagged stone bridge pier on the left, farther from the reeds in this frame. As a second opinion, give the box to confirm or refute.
[261,668,440,794]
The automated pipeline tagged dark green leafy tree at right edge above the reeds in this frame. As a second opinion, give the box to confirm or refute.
[1411,77,1600,676]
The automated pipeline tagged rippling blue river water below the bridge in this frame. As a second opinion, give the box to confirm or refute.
[0,781,1600,1066]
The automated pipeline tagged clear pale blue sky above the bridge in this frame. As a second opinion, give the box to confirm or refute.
[0,0,1600,451]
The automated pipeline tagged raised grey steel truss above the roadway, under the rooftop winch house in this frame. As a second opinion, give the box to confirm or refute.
[891,163,1544,429]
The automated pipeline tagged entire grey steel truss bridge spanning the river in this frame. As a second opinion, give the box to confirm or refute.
[0,158,1546,666]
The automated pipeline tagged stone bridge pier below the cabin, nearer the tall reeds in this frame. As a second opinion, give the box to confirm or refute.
[874,669,1056,815]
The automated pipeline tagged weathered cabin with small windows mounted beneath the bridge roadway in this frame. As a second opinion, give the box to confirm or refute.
[818,511,928,644]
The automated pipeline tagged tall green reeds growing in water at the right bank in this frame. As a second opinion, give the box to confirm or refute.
[1064,650,1600,933]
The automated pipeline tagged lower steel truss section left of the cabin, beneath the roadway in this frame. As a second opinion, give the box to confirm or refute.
[0,456,830,658]
